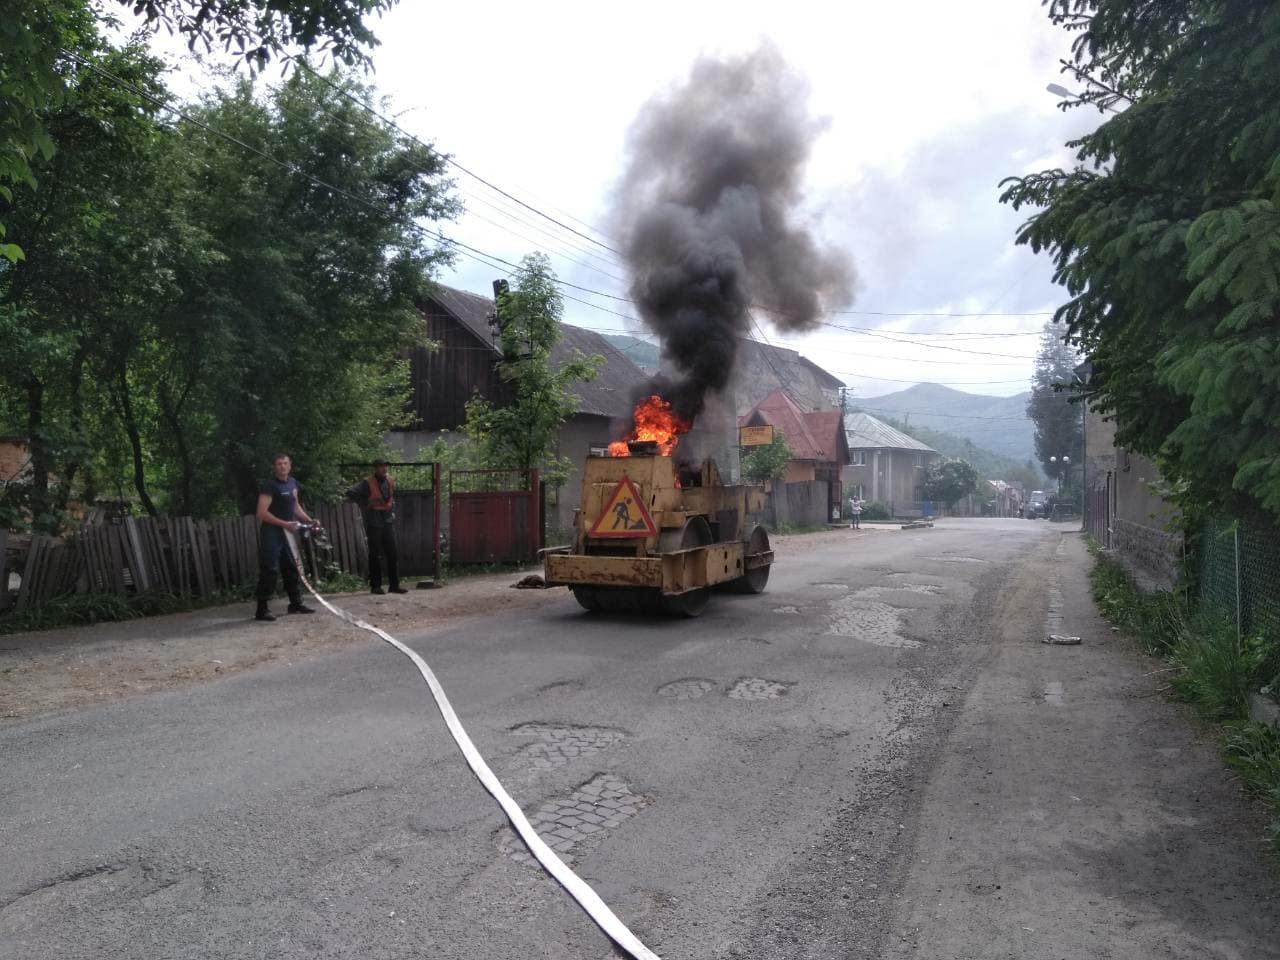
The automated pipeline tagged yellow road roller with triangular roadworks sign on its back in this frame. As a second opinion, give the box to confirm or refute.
[544,415,773,617]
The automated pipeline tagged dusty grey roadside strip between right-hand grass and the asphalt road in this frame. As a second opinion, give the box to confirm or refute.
[884,536,1280,960]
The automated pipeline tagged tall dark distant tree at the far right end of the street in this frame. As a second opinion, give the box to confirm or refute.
[1027,323,1084,483]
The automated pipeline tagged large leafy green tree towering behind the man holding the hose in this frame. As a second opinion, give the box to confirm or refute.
[163,70,457,511]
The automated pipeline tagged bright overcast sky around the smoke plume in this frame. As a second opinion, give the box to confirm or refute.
[129,0,1098,397]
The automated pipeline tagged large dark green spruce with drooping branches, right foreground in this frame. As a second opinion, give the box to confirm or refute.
[1002,0,1280,516]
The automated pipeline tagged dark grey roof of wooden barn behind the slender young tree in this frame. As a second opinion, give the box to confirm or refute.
[430,284,649,417]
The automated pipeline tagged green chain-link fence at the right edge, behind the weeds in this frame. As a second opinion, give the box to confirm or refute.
[1199,515,1280,636]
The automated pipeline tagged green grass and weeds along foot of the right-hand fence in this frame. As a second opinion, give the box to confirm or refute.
[1089,550,1280,855]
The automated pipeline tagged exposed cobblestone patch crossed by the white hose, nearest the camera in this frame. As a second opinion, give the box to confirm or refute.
[498,773,649,864]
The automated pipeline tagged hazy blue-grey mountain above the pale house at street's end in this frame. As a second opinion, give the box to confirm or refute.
[850,383,1036,463]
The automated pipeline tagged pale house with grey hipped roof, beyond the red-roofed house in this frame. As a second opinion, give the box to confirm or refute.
[842,413,941,517]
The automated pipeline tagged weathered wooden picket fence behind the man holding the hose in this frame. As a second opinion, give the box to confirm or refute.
[0,503,369,611]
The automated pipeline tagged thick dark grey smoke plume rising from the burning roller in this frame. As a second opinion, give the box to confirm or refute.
[614,46,854,422]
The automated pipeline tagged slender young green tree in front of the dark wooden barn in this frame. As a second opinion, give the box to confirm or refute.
[463,253,604,484]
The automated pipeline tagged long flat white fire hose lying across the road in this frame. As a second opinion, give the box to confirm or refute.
[285,524,659,960]
